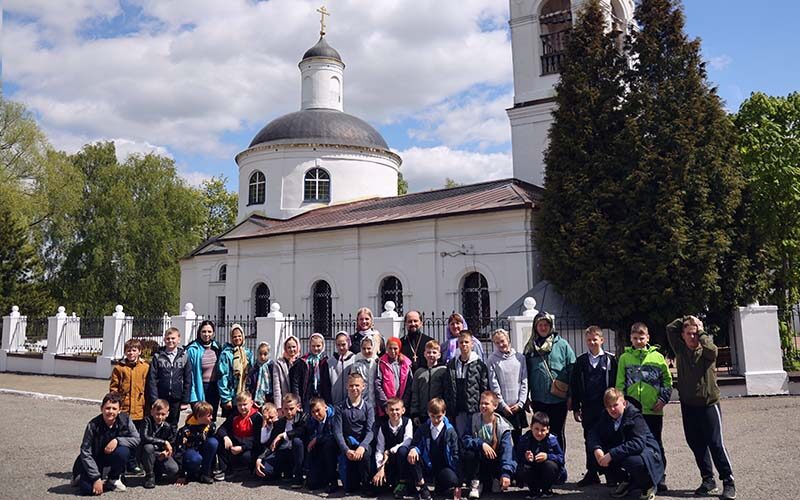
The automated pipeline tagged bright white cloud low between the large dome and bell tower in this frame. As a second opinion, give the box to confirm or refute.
[397,146,512,192]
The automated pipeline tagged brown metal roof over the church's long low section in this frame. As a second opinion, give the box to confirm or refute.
[197,179,542,255]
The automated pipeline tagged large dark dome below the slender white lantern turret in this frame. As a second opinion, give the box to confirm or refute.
[250,109,389,151]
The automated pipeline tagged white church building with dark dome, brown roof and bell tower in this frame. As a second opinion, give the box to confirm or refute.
[180,0,634,333]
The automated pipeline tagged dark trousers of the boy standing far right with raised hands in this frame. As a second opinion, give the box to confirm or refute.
[681,403,733,480]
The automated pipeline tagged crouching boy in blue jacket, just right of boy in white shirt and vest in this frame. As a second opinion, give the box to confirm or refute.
[408,398,461,500]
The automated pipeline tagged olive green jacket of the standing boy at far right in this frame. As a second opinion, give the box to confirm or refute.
[667,318,719,406]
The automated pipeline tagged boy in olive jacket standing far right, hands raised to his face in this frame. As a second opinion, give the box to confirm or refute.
[667,316,736,500]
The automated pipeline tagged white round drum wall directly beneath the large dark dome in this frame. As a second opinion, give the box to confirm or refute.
[237,145,400,222]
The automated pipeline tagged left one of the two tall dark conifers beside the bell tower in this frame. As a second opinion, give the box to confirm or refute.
[536,0,630,322]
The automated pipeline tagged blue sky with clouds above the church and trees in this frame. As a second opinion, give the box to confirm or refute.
[3,0,800,190]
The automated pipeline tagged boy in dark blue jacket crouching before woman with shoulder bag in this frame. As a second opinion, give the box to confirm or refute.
[516,411,567,498]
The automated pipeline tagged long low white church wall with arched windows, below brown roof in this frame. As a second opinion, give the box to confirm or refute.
[181,209,537,315]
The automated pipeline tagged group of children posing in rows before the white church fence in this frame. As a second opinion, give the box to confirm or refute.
[73,314,736,500]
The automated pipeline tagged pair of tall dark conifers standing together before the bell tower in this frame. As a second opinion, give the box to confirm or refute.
[540,0,742,340]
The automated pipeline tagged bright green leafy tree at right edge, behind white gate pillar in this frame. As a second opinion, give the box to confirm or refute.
[735,92,800,314]
